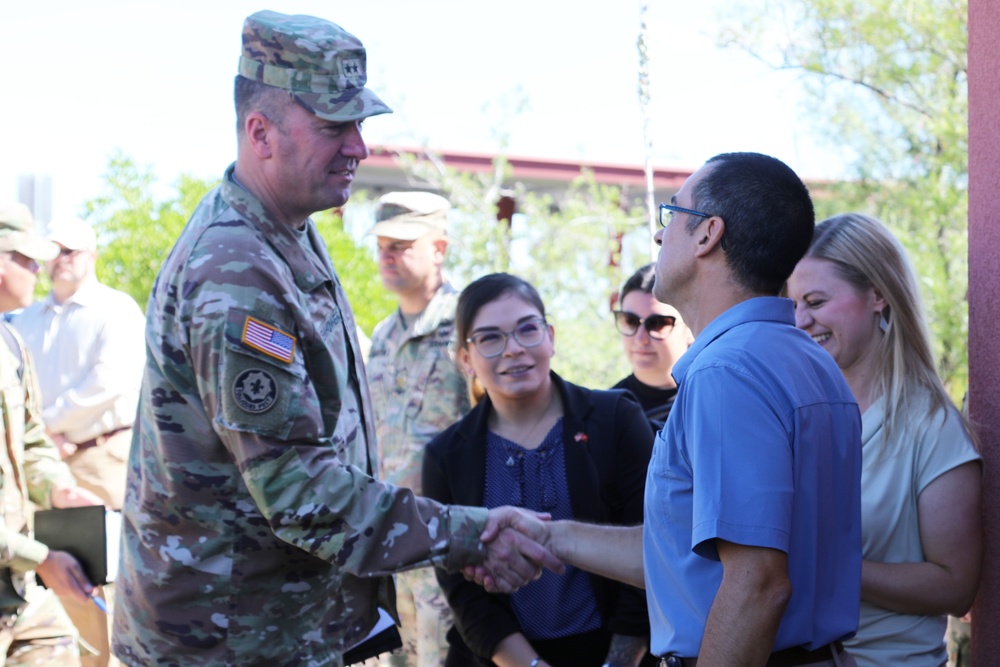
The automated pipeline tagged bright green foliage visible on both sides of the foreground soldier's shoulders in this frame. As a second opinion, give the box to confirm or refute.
[84,154,394,333]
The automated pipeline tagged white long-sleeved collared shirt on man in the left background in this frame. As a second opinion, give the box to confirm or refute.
[13,277,146,442]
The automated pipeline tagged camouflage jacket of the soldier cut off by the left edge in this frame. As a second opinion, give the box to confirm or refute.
[0,324,76,610]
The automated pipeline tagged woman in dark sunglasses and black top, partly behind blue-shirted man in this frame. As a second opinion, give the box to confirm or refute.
[613,264,694,431]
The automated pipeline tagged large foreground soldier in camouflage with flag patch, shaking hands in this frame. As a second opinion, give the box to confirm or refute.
[113,11,553,667]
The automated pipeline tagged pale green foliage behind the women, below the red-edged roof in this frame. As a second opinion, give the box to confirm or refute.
[401,150,649,388]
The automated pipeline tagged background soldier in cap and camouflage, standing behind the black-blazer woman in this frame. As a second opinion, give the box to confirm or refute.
[368,192,469,667]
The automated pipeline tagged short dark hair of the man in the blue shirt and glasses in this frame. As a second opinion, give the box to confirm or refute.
[689,153,816,295]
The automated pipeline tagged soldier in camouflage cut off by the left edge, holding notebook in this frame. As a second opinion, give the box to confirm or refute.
[0,204,101,667]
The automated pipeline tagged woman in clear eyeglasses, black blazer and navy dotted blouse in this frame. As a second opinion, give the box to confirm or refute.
[423,273,655,667]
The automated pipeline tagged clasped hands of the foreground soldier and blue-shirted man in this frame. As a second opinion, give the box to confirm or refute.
[464,507,566,593]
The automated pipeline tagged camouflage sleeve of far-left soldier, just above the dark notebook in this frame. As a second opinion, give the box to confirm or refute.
[19,328,76,506]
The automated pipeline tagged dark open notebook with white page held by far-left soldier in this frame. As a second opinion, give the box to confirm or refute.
[35,505,121,586]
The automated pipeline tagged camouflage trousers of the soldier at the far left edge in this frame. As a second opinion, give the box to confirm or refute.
[0,588,81,667]
